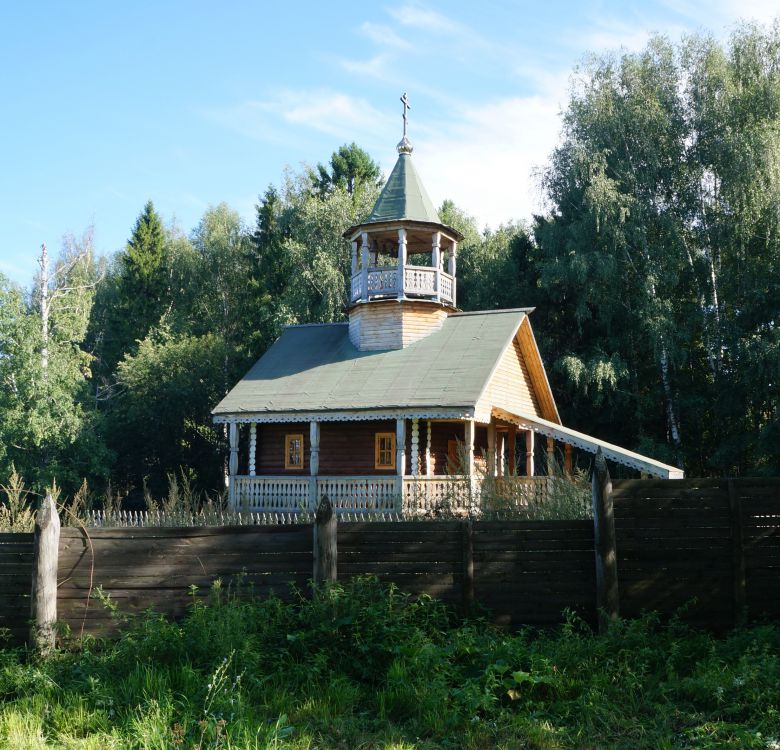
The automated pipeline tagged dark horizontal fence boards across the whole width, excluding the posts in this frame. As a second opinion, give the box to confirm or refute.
[0,479,780,639]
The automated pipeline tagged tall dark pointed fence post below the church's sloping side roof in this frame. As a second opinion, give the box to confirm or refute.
[592,448,620,633]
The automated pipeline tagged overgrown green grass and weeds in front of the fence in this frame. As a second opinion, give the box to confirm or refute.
[0,579,780,750]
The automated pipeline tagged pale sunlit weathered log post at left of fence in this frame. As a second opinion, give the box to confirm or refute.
[30,492,60,656]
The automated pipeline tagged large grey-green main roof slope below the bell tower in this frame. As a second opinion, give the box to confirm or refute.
[213,310,525,415]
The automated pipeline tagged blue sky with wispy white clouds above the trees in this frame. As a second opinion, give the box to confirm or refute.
[0,0,778,284]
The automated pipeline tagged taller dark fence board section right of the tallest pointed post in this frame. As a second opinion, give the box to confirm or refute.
[612,479,780,627]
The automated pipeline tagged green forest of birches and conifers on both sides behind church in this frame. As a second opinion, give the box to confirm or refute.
[0,23,780,502]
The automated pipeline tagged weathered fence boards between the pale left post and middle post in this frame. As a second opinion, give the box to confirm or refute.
[57,525,312,634]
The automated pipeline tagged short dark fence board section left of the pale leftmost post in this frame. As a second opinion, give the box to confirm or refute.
[0,534,33,644]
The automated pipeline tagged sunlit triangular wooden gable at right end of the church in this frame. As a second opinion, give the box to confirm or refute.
[476,317,560,424]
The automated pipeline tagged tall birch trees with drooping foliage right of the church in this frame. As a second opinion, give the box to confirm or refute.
[535,26,780,473]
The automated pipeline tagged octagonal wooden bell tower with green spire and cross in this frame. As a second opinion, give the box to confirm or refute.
[344,94,463,351]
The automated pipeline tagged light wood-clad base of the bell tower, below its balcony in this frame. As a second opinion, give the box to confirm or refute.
[349,300,447,351]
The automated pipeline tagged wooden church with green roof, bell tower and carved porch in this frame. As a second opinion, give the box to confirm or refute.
[213,102,683,510]
